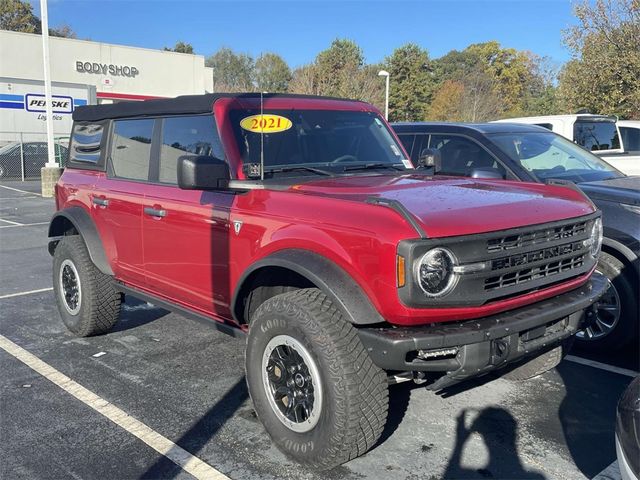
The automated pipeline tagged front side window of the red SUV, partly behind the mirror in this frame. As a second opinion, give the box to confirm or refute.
[158,115,224,184]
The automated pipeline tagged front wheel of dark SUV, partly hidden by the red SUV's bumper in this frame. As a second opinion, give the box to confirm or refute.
[576,252,640,350]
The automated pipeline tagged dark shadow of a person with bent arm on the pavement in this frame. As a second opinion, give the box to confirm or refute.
[443,407,545,480]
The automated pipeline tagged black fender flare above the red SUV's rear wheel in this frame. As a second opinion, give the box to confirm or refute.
[49,207,113,276]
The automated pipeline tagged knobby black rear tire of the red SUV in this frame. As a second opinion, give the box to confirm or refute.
[53,235,122,337]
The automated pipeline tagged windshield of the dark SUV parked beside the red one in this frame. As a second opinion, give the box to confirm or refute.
[489,132,623,182]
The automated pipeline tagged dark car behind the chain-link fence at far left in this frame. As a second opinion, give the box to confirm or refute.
[0,142,69,178]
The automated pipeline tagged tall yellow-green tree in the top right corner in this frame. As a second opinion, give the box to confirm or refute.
[559,0,640,118]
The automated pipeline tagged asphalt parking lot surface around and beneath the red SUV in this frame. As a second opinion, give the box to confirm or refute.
[0,182,638,479]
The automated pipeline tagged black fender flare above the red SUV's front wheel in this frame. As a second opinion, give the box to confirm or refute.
[231,249,385,325]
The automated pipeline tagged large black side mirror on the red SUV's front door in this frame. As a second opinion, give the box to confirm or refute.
[178,155,230,190]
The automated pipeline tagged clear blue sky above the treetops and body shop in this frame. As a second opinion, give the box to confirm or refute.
[40,0,575,67]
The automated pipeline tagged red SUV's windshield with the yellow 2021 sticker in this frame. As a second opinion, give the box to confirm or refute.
[230,109,413,174]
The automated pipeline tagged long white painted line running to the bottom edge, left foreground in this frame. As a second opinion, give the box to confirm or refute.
[0,335,229,480]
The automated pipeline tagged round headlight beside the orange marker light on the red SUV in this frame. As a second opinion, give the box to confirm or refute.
[414,248,458,297]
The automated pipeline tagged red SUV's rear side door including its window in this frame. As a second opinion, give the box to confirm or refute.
[91,119,155,286]
